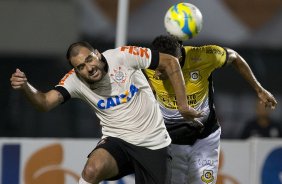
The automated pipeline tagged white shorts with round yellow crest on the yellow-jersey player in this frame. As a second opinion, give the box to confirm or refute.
[171,128,221,184]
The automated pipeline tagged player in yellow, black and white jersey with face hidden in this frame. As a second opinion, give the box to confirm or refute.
[145,36,277,184]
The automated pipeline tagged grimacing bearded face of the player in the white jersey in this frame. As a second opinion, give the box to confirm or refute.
[71,47,106,83]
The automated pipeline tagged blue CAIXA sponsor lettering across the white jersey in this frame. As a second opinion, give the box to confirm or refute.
[97,84,139,109]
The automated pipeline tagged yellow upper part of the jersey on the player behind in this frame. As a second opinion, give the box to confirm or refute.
[145,45,227,109]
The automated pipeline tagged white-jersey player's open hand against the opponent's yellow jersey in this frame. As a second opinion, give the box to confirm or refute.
[179,107,204,128]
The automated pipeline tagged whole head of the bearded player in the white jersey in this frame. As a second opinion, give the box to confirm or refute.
[66,42,106,83]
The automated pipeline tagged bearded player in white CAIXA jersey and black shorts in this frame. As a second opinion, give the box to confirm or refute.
[10,42,201,184]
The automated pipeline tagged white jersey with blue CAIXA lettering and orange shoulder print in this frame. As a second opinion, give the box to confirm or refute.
[56,46,171,149]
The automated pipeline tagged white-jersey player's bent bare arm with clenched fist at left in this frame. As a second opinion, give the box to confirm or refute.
[10,69,63,111]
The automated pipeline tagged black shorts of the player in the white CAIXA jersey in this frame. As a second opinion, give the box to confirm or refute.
[89,137,171,184]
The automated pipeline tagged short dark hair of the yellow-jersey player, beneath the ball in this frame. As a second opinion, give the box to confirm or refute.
[152,35,182,57]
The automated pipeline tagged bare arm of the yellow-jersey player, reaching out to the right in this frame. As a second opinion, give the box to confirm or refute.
[227,49,277,109]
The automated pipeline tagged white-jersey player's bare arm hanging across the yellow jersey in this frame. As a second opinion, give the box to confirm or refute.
[157,53,202,126]
